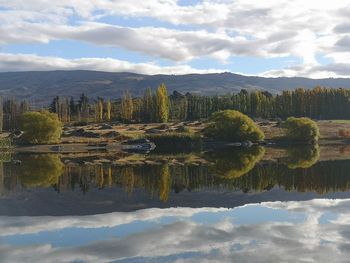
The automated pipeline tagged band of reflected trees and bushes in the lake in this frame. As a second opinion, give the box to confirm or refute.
[0,146,350,202]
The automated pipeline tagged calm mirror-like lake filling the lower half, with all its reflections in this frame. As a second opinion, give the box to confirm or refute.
[0,146,350,262]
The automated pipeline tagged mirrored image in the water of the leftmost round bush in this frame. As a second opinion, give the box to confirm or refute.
[19,154,63,187]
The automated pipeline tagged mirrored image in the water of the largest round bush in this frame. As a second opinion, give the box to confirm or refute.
[206,146,265,179]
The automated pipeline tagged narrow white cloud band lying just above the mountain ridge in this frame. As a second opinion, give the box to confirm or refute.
[0,53,222,75]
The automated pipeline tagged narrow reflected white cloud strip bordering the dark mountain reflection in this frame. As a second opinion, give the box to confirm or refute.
[0,207,227,237]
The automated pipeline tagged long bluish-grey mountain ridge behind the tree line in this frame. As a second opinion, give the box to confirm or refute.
[0,70,350,102]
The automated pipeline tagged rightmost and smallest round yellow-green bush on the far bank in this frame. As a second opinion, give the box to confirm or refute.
[283,117,320,143]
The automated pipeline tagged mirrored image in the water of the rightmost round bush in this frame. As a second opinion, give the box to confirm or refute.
[286,144,320,169]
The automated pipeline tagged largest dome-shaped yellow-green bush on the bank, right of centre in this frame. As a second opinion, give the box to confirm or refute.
[203,110,265,142]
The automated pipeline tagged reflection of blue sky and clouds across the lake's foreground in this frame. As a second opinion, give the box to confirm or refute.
[0,199,350,262]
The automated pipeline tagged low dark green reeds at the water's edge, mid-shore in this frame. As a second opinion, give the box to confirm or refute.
[147,132,202,152]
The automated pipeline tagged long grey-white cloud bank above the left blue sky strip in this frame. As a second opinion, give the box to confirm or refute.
[0,23,292,62]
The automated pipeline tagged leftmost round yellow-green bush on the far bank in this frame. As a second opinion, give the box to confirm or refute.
[21,111,62,144]
